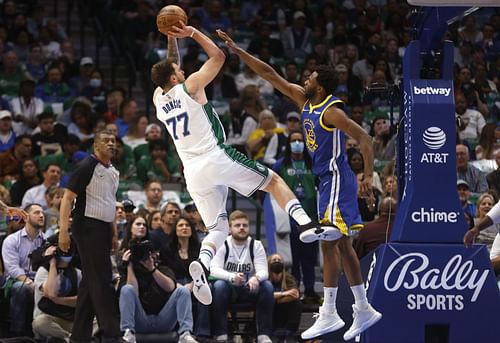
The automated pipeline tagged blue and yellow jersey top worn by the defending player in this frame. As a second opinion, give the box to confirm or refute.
[302,95,349,177]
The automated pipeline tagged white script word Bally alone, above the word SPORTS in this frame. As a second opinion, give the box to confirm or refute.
[384,252,489,302]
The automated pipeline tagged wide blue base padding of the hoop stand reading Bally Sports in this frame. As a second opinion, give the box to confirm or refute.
[356,243,500,343]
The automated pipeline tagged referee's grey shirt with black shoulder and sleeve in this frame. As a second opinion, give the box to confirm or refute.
[66,156,120,223]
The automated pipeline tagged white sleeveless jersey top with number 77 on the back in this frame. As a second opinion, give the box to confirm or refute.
[153,83,226,161]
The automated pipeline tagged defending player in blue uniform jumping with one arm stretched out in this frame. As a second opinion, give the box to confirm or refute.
[217,30,382,341]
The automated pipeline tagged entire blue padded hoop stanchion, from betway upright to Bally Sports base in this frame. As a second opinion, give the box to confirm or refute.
[360,41,500,343]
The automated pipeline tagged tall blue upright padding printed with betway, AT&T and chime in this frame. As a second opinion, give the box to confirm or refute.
[391,42,467,243]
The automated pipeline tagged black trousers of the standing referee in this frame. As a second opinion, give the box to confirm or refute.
[71,217,121,343]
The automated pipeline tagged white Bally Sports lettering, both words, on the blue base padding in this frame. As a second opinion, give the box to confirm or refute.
[384,252,489,311]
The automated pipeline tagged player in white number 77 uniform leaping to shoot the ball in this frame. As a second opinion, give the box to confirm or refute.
[151,16,342,305]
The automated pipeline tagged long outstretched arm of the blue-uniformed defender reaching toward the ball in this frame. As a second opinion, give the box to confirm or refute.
[217,30,306,108]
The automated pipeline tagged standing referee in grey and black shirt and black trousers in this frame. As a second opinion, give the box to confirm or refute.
[59,130,121,343]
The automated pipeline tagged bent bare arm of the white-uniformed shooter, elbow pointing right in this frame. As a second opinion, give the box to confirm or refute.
[168,21,226,94]
